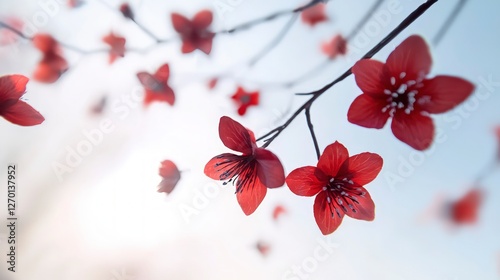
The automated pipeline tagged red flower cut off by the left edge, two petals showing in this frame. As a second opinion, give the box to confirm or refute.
[0,75,45,126]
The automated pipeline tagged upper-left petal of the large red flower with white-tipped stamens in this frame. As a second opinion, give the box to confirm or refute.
[351,59,387,97]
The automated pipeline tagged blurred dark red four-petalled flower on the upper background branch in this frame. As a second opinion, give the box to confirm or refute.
[172,10,215,54]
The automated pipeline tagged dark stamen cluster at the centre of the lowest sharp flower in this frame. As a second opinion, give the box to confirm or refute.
[323,178,366,218]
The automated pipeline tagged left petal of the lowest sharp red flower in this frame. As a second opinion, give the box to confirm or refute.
[286,166,328,196]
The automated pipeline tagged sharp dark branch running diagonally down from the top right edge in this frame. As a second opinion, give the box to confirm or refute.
[261,0,438,148]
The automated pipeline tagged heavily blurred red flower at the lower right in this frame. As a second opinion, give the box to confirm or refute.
[449,188,483,225]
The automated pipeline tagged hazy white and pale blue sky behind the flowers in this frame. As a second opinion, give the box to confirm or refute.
[0,0,500,280]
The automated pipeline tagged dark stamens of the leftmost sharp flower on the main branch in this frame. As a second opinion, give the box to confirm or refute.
[215,155,257,192]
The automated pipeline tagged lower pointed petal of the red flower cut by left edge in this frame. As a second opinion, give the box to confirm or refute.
[1,101,45,126]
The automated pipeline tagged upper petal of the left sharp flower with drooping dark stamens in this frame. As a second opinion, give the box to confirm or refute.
[219,116,253,155]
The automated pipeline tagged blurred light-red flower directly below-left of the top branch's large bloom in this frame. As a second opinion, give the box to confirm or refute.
[137,64,175,105]
